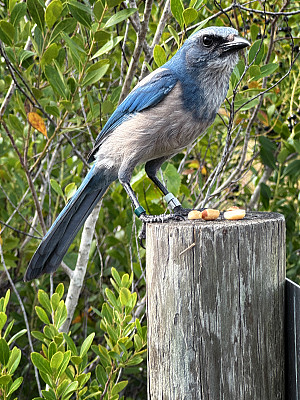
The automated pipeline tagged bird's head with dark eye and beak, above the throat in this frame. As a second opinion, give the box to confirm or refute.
[170,26,250,77]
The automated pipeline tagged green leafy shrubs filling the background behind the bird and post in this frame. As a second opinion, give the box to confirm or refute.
[0,0,300,400]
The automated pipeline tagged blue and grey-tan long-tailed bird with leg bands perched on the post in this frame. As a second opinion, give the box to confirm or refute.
[24,27,250,281]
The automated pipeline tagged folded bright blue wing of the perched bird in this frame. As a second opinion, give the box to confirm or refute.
[88,68,178,162]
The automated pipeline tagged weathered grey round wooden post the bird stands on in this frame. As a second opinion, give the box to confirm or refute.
[147,213,288,400]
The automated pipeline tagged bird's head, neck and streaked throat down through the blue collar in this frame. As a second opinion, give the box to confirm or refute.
[163,26,250,120]
